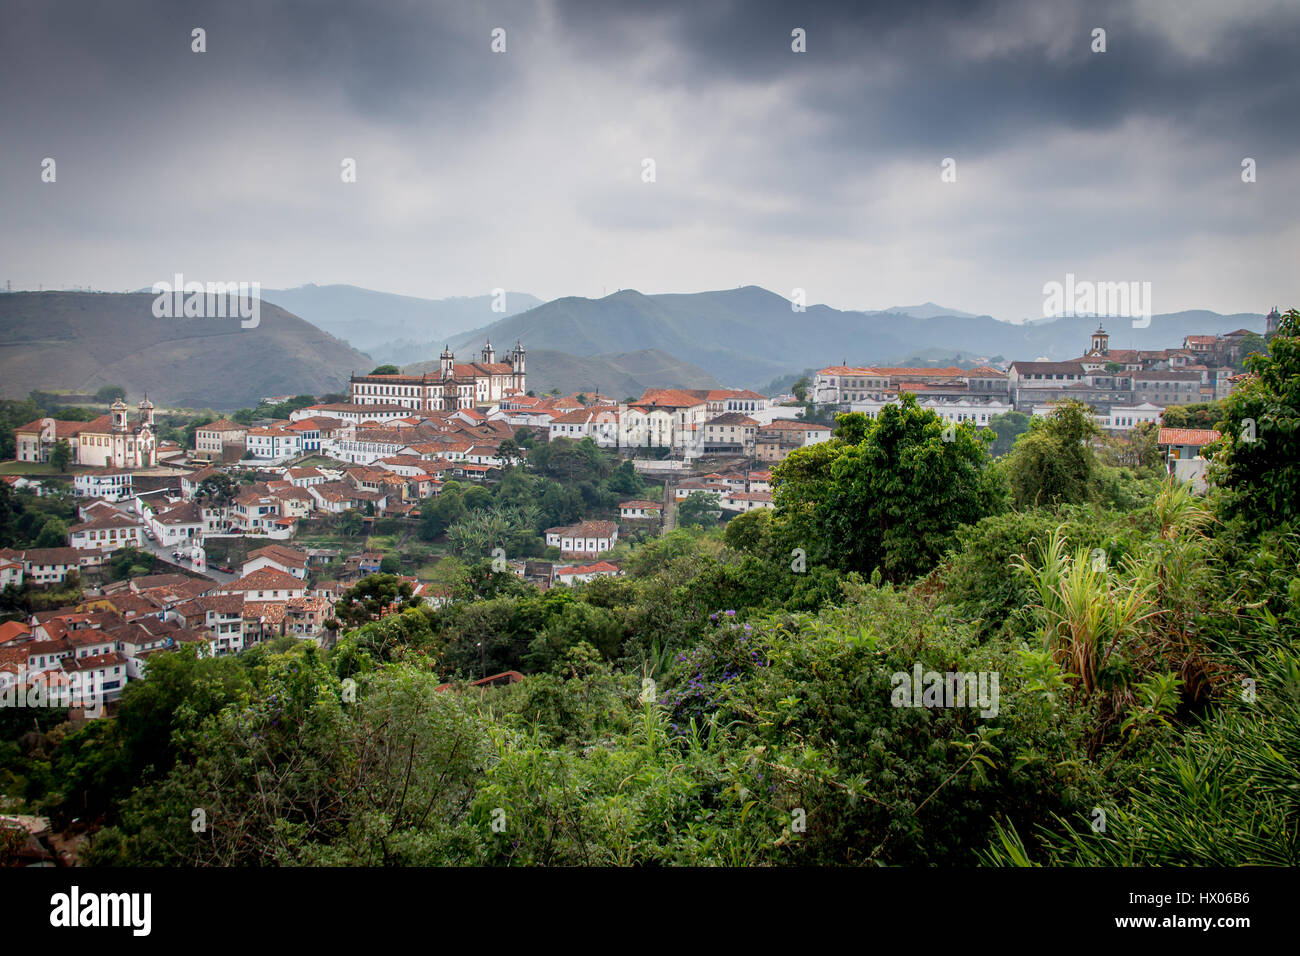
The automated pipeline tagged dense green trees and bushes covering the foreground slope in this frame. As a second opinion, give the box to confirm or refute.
[0,311,1300,865]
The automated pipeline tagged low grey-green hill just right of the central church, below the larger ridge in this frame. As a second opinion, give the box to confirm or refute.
[403,349,719,398]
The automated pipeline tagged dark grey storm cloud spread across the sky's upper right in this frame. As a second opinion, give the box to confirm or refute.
[560,0,1300,151]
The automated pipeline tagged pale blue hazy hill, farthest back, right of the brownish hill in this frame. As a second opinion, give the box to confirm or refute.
[261,285,542,364]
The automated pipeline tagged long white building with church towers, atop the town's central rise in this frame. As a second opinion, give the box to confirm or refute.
[351,339,528,411]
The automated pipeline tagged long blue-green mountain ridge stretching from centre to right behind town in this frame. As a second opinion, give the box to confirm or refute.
[451,286,1264,388]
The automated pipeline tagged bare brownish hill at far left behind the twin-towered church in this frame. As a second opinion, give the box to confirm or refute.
[0,291,374,410]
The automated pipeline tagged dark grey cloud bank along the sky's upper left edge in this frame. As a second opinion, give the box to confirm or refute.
[0,0,536,122]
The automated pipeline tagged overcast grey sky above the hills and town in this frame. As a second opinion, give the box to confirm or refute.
[0,0,1300,321]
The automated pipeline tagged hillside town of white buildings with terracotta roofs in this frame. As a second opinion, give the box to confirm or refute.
[0,310,1278,723]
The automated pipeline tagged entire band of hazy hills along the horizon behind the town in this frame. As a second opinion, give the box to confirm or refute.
[0,280,1264,410]
